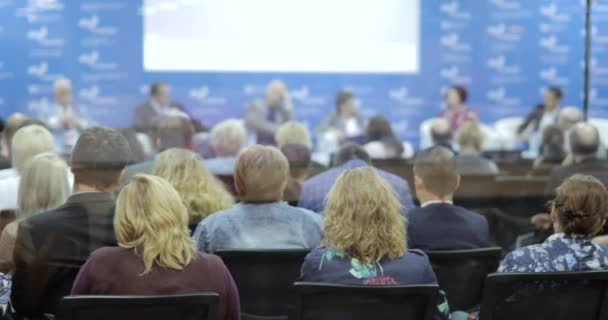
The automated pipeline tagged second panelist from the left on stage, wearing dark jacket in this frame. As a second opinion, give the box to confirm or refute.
[133,81,206,133]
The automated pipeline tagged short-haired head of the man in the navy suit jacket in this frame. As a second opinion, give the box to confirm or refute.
[414,146,460,197]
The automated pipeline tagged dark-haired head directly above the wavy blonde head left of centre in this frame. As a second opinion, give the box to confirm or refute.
[153,114,194,152]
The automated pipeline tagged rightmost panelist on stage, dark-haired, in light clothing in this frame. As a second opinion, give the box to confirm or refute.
[517,87,563,155]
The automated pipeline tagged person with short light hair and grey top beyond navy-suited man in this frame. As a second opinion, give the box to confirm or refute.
[456,121,499,175]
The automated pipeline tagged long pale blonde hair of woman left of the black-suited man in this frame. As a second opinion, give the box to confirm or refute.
[17,153,70,219]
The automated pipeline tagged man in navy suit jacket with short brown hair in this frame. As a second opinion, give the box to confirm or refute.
[408,146,490,250]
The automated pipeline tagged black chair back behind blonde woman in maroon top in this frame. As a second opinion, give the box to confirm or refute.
[57,293,219,320]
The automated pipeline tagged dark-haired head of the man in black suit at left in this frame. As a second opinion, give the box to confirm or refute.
[70,127,129,192]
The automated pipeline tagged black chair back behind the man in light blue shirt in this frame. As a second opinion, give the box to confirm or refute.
[215,249,310,318]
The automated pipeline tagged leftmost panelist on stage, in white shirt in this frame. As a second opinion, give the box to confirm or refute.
[41,78,91,154]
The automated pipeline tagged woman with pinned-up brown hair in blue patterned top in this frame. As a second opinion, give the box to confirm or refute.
[498,175,608,272]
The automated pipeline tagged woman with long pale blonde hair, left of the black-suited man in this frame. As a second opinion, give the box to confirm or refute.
[0,153,71,273]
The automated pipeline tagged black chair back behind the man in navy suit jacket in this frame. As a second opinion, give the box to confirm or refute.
[426,247,502,310]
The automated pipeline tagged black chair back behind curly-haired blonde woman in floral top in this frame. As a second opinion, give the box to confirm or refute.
[289,282,438,320]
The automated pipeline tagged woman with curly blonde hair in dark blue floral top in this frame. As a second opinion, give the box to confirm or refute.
[300,167,449,318]
